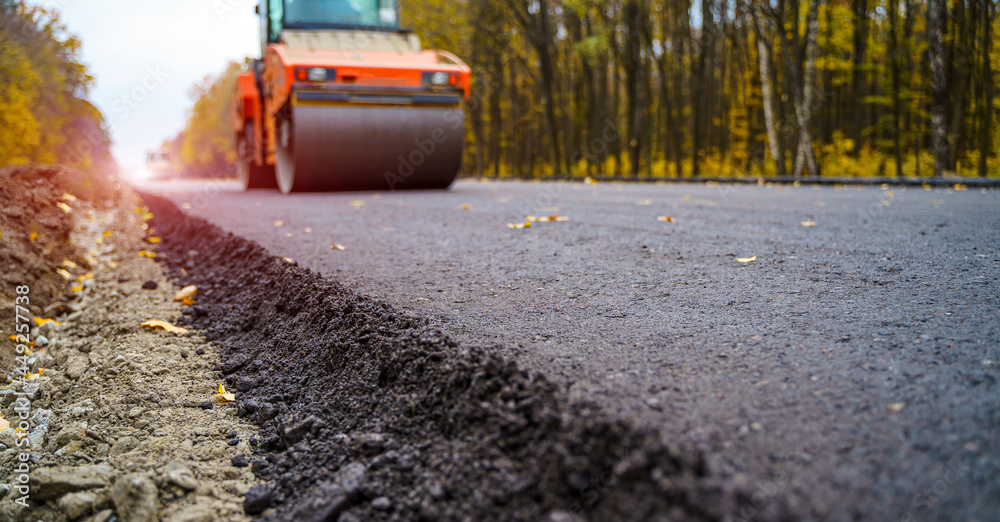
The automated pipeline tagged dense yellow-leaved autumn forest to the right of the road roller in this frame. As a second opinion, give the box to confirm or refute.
[404,0,1000,176]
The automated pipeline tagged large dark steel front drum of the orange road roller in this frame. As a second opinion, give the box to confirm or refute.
[276,105,465,194]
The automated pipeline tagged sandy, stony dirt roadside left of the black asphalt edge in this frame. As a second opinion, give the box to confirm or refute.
[0,168,256,521]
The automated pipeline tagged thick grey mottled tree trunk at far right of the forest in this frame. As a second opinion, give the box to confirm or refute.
[927,0,949,177]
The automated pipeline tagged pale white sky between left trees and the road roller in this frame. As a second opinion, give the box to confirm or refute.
[35,0,260,170]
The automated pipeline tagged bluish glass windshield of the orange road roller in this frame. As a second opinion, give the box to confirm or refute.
[275,0,399,29]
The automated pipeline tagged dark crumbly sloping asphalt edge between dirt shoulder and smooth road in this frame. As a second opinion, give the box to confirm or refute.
[145,196,736,521]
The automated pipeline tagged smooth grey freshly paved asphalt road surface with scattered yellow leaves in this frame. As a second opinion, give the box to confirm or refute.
[145,177,1000,520]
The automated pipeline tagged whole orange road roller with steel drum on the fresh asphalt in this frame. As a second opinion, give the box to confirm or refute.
[233,0,471,193]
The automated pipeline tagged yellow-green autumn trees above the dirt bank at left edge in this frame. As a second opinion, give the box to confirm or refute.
[0,0,114,173]
